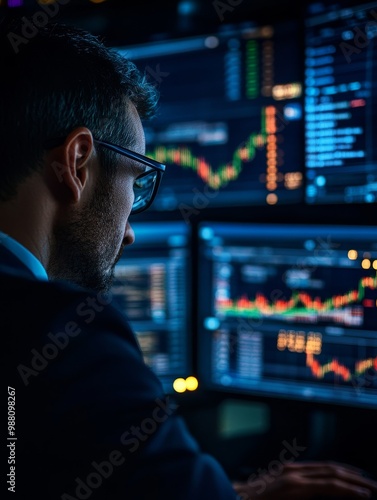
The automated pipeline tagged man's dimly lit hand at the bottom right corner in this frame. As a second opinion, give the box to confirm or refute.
[233,462,377,500]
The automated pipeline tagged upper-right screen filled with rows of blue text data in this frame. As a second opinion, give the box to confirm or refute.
[305,1,377,204]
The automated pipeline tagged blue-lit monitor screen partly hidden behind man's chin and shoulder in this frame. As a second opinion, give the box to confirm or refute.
[111,221,192,392]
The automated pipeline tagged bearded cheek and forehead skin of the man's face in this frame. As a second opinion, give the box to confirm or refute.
[47,106,145,291]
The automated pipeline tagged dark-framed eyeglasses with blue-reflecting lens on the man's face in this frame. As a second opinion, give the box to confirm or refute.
[45,137,166,215]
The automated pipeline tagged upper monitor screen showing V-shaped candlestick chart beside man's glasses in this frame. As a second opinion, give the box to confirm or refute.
[114,22,304,212]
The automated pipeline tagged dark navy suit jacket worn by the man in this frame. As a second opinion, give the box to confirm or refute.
[0,245,236,500]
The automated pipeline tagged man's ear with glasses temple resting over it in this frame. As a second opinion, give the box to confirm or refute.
[47,127,94,203]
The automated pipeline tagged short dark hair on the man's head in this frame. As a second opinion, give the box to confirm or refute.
[0,20,158,201]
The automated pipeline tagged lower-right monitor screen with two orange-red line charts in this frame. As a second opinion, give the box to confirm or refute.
[199,222,377,408]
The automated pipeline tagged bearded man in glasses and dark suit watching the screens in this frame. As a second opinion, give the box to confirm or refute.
[0,20,377,500]
